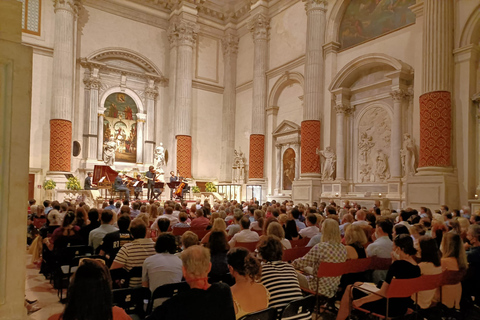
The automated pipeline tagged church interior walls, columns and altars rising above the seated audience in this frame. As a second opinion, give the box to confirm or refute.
[0,0,480,319]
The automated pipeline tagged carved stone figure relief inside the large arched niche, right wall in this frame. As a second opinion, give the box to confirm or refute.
[357,106,392,182]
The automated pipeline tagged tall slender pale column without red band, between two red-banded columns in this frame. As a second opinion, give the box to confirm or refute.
[220,30,239,182]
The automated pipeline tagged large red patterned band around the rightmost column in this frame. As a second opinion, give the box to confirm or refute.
[418,91,452,167]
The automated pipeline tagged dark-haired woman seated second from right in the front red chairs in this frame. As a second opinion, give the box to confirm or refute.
[417,236,442,309]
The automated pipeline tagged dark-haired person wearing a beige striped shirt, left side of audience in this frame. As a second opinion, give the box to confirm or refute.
[110,219,155,287]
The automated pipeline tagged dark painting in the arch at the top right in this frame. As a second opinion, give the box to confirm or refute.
[339,0,415,49]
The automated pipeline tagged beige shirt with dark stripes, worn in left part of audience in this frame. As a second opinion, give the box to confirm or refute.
[114,238,156,287]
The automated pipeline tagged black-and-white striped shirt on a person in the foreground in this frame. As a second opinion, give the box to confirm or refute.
[261,261,311,319]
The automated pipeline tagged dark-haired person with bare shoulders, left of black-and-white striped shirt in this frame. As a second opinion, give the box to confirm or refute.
[227,247,270,319]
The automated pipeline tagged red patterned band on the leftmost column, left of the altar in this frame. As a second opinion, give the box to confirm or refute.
[49,119,72,172]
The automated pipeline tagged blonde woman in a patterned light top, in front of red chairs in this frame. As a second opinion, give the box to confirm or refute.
[292,218,347,298]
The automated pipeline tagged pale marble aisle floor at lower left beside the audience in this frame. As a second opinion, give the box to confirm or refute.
[25,254,63,320]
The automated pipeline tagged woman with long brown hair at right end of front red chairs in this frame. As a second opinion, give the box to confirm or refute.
[441,232,468,309]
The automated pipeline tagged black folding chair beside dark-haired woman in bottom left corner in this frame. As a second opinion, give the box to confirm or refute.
[113,287,152,319]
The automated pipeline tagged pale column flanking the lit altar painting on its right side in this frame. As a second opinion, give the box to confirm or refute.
[144,79,158,164]
